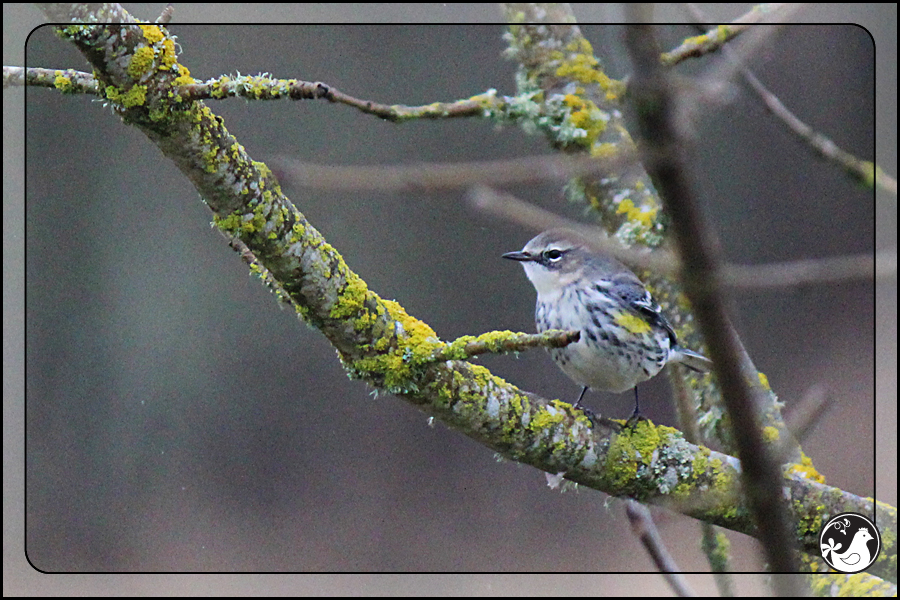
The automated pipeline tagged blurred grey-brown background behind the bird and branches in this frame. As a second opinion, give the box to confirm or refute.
[4,4,897,594]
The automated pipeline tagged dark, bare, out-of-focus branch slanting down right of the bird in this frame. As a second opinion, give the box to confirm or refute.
[626,19,801,584]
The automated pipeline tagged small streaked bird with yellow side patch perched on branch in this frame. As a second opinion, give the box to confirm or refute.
[503,229,712,415]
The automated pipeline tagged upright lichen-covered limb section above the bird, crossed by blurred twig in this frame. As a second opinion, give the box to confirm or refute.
[497,4,652,247]
